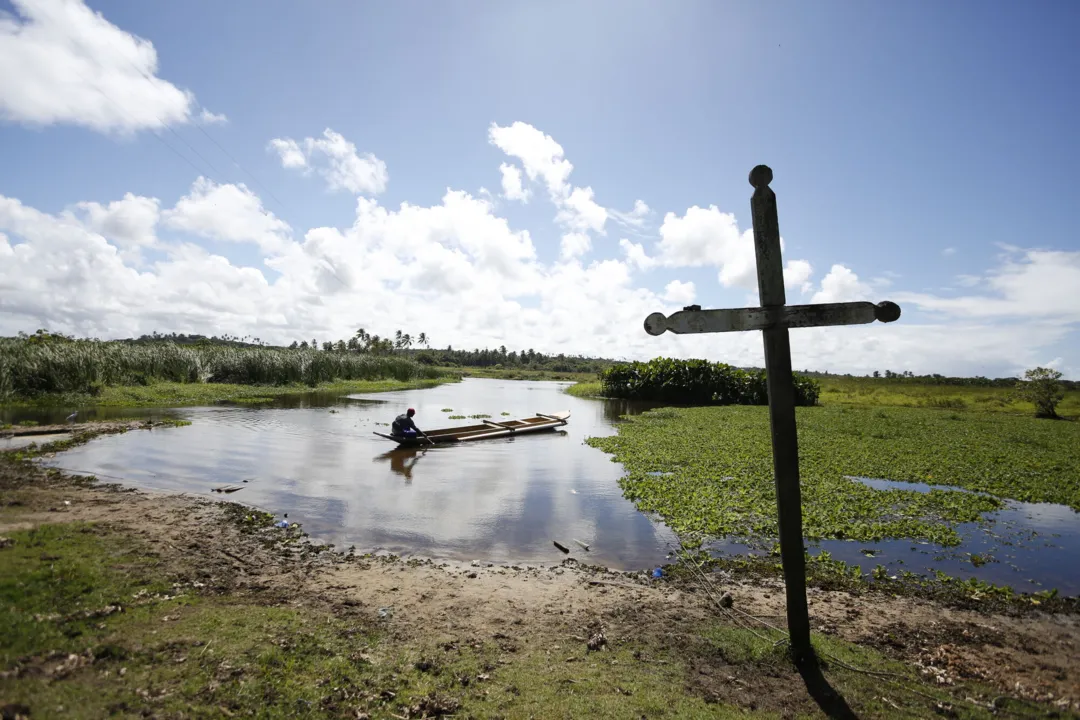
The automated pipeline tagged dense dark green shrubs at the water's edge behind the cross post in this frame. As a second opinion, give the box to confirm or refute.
[599,357,821,405]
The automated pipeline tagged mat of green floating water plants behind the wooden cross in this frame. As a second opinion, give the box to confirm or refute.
[588,407,1080,546]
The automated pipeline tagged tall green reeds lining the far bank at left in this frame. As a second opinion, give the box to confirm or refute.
[0,339,441,398]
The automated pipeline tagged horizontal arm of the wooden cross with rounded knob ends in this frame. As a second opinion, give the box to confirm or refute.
[645,300,900,335]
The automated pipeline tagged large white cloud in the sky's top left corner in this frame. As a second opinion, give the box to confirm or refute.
[0,0,225,133]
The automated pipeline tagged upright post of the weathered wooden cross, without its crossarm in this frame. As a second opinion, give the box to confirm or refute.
[750,165,812,664]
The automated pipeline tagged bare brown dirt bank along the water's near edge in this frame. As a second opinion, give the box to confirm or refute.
[0,446,1080,715]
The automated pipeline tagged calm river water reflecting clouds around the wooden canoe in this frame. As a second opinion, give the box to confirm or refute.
[12,379,1080,595]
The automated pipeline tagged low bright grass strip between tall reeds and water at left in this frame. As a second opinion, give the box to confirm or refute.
[5,376,459,407]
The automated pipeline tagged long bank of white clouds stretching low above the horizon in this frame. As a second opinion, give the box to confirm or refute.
[0,118,1080,376]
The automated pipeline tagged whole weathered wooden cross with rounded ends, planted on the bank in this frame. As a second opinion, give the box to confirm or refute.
[645,165,900,664]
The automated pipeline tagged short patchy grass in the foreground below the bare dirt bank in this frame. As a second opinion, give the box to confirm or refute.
[0,524,1035,720]
